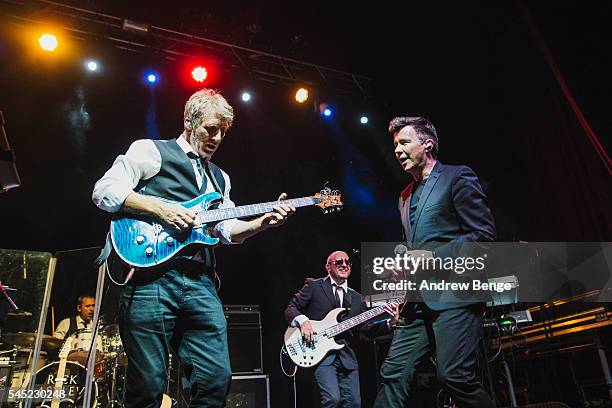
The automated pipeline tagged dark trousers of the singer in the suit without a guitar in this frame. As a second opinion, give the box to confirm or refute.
[374,303,495,408]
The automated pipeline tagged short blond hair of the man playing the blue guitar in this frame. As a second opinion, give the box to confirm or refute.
[183,88,234,130]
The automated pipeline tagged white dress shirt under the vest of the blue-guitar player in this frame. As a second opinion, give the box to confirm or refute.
[92,134,238,244]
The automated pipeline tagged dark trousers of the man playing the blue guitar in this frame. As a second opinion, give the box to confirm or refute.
[119,269,231,408]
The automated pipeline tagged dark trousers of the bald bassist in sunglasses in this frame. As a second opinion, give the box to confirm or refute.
[314,356,361,408]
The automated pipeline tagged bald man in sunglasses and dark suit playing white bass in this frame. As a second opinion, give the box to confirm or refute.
[285,251,399,408]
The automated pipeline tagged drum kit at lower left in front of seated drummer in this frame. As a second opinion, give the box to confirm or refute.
[0,318,127,408]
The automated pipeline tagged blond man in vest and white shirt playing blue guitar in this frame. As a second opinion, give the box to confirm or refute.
[92,89,295,408]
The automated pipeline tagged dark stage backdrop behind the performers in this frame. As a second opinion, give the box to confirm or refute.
[0,1,612,406]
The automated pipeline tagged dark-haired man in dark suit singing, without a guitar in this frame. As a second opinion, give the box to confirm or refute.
[374,117,495,408]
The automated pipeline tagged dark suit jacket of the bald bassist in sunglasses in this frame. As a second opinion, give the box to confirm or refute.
[285,276,388,370]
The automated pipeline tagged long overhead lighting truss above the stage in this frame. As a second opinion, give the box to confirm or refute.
[0,0,372,97]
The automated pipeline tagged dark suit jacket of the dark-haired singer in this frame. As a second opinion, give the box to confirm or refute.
[399,162,495,310]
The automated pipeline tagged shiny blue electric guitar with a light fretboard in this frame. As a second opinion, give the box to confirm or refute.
[110,188,342,268]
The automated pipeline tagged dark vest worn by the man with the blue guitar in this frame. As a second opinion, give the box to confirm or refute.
[135,139,225,268]
